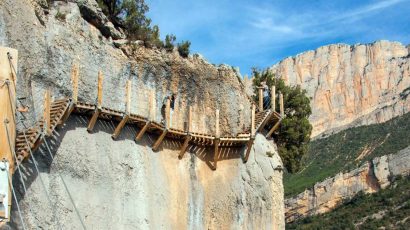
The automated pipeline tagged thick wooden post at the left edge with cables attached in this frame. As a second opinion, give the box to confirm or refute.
[0,47,18,221]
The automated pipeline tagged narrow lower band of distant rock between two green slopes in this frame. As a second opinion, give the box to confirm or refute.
[285,146,410,222]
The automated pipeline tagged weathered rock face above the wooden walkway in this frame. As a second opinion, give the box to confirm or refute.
[0,0,251,135]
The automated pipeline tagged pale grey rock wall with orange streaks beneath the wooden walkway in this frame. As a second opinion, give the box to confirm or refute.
[12,116,284,229]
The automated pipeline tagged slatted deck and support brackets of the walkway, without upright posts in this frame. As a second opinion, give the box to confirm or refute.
[16,98,281,168]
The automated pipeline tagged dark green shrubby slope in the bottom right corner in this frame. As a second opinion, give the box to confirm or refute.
[286,177,410,229]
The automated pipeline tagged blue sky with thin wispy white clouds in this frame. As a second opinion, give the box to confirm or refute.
[147,0,410,75]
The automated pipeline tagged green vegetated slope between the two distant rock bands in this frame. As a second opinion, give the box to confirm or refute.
[284,113,410,197]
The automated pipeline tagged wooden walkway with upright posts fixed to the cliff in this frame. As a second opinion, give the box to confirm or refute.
[15,65,284,169]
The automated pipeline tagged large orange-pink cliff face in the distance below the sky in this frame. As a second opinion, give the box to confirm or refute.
[270,41,410,137]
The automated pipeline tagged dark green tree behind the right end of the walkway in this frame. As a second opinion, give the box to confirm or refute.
[252,68,312,173]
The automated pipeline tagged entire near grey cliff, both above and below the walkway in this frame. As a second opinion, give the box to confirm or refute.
[0,0,284,229]
